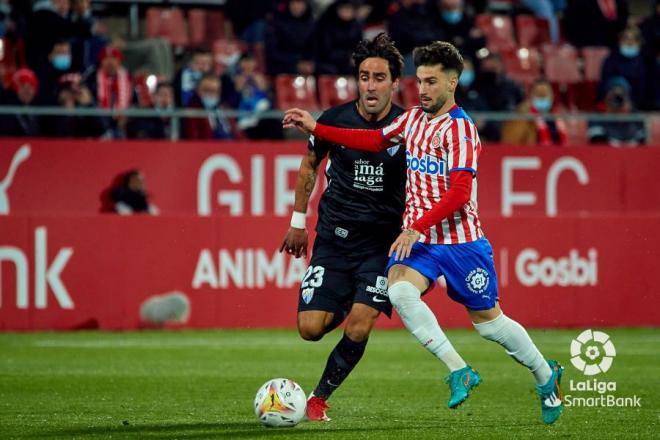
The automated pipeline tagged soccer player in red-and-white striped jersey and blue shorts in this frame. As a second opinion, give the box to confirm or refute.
[283,41,563,423]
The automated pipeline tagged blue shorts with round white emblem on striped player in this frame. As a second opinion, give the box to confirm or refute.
[385,238,497,310]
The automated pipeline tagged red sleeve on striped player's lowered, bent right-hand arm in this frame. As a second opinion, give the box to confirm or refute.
[410,171,472,234]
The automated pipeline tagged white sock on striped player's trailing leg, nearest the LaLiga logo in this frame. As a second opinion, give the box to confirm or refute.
[472,313,552,385]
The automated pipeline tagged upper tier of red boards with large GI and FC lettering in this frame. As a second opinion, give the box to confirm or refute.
[0,138,660,217]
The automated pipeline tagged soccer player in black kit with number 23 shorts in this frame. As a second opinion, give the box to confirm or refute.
[280,33,406,421]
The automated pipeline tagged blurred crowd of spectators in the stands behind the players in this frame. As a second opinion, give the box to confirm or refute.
[0,0,660,145]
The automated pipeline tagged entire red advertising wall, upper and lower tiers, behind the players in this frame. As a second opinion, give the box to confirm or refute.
[0,140,660,330]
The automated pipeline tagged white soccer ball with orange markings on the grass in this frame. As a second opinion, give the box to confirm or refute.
[254,378,307,427]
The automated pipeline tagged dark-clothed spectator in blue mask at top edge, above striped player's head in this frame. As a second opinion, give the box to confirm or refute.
[436,0,486,57]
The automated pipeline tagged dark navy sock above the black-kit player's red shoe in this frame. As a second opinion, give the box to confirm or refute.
[314,334,367,399]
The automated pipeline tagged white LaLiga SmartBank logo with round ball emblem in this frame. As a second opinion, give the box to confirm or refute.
[564,329,642,408]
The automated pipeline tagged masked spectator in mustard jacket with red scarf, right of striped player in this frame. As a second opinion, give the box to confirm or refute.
[502,79,567,146]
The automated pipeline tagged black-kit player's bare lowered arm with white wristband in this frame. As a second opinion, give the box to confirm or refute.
[280,150,321,258]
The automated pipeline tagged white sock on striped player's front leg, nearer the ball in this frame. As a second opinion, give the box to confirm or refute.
[387,281,467,371]
